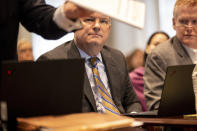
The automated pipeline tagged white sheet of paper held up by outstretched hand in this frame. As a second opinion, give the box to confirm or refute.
[70,0,146,29]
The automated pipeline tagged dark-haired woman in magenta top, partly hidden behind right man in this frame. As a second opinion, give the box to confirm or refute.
[129,32,169,111]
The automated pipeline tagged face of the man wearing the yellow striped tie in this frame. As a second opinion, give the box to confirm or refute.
[75,13,111,55]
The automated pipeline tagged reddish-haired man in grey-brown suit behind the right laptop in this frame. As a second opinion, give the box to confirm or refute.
[144,0,197,110]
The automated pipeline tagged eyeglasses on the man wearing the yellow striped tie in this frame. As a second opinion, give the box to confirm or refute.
[81,17,111,26]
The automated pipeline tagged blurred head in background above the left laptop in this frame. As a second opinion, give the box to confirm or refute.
[17,40,34,62]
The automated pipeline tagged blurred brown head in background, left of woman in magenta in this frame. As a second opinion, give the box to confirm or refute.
[126,49,144,72]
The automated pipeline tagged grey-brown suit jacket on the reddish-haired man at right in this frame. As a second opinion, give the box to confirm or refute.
[144,37,192,110]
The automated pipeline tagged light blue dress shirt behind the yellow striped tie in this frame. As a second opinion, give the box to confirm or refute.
[78,48,111,113]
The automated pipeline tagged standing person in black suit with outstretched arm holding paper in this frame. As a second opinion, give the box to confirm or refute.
[0,0,89,62]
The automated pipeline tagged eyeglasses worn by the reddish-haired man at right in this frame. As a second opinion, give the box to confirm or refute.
[177,19,197,29]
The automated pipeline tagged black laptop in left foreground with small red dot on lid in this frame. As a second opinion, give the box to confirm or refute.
[0,59,85,122]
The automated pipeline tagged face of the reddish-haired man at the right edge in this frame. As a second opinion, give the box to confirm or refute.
[173,5,197,49]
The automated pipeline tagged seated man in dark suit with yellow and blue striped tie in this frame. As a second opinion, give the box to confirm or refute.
[38,12,141,115]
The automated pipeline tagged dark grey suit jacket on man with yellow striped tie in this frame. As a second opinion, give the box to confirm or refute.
[38,41,141,113]
